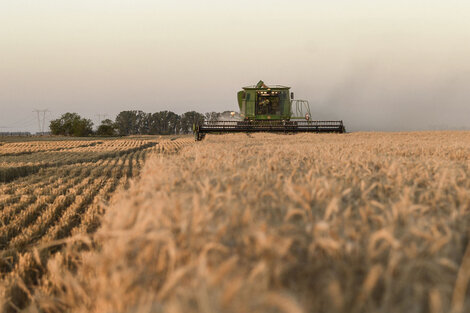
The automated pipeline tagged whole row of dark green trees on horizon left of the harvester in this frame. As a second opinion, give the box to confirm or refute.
[49,110,230,137]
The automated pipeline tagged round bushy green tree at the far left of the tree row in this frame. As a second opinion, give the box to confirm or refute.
[49,113,93,137]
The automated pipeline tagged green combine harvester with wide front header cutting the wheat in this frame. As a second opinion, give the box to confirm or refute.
[193,81,346,140]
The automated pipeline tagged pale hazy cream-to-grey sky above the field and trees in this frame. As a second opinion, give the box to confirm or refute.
[0,0,470,131]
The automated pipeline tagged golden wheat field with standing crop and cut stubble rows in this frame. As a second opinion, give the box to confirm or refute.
[0,131,470,313]
